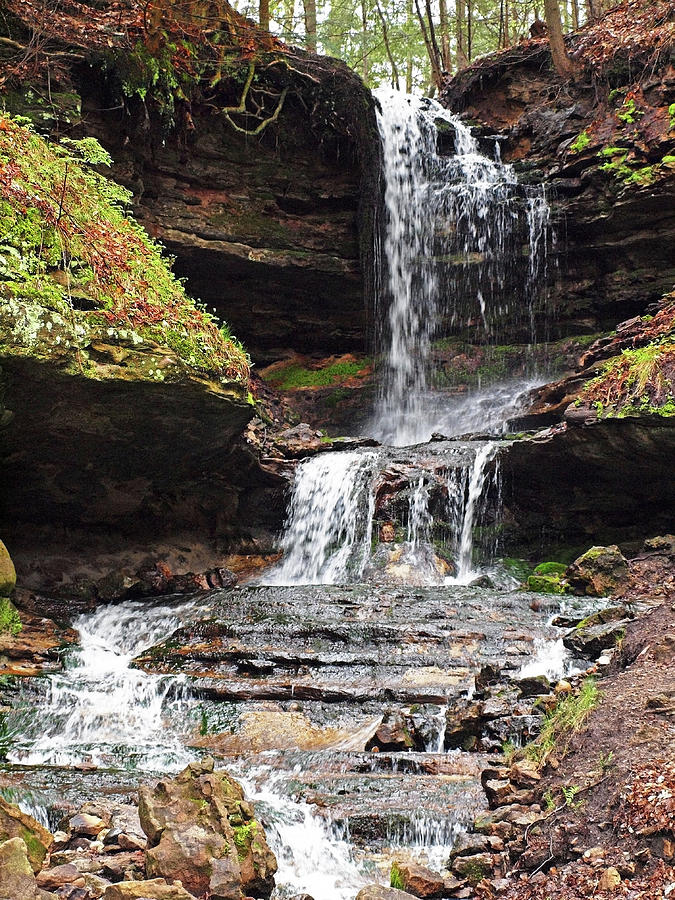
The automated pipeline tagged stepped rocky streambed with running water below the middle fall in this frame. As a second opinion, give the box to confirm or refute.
[0,544,656,900]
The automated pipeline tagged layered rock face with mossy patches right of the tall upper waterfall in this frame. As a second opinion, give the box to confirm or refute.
[443,8,675,334]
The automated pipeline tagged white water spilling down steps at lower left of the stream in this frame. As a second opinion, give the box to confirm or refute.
[9,599,197,772]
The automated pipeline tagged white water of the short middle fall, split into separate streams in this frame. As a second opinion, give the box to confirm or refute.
[260,441,498,585]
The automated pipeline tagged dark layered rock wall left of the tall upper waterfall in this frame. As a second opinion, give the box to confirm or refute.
[74,55,379,363]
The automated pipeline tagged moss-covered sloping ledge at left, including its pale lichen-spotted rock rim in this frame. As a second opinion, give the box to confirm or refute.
[0,115,249,385]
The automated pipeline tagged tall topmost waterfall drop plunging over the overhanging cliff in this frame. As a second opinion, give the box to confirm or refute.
[369,90,549,446]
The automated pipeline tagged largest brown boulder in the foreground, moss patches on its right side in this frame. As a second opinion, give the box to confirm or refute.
[139,758,277,900]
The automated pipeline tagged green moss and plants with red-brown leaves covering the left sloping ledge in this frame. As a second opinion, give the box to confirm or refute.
[0,116,250,380]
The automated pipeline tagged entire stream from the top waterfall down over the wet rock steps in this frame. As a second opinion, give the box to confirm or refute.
[3,92,572,900]
